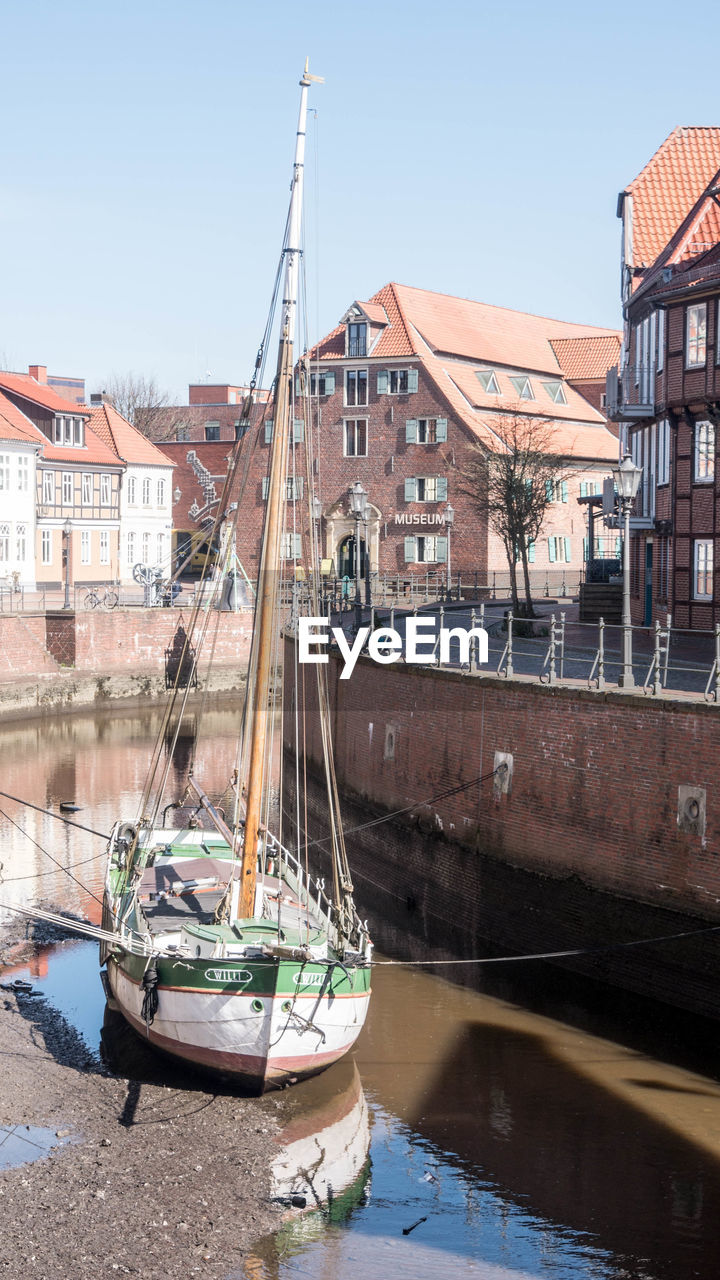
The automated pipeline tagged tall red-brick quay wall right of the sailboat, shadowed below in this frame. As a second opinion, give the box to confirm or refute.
[284,639,720,1018]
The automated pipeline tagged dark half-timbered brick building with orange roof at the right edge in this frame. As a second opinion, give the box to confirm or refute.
[607,128,720,630]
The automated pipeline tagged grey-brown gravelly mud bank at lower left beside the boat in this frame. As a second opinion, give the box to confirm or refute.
[0,929,284,1280]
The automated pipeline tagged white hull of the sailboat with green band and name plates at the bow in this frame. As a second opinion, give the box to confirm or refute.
[108,952,370,1092]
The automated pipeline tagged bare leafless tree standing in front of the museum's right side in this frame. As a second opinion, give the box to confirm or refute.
[461,413,568,618]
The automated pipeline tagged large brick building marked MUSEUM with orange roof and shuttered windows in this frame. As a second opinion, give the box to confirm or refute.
[164,284,620,582]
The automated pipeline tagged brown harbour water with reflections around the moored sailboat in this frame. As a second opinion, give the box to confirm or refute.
[0,710,720,1280]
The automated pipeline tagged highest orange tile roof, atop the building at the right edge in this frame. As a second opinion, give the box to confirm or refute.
[623,127,720,266]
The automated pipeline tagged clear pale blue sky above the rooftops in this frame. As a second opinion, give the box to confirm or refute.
[0,0,720,401]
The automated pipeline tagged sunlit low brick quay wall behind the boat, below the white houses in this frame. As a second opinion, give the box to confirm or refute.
[0,608,251,719]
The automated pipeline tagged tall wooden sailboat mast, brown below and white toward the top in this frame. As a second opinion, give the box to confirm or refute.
[237,61,322,919]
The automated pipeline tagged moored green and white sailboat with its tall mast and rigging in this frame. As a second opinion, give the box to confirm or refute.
[100,64,372,1092]
